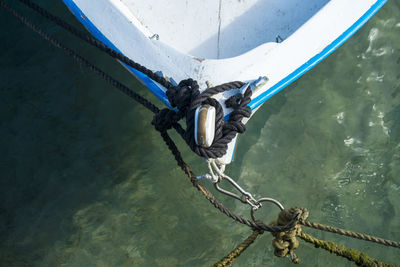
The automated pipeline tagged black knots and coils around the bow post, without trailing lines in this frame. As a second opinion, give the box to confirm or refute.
[152,79,252,158]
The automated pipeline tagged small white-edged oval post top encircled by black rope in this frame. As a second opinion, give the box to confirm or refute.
[194,104,215,147]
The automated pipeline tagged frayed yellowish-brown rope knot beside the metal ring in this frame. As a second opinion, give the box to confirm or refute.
[271,207,308,264]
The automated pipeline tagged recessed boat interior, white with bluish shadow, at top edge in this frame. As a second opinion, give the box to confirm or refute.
[121,0,329,59]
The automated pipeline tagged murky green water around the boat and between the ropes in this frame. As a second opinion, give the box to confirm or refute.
[0,0,400,266]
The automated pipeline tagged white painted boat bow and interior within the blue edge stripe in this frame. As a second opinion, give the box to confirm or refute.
[68,0,376,163]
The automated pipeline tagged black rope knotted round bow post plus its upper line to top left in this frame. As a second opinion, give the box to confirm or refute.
[18,0,251,158]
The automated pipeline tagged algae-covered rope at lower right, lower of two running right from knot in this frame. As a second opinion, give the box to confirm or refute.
[298,232,396,267]
